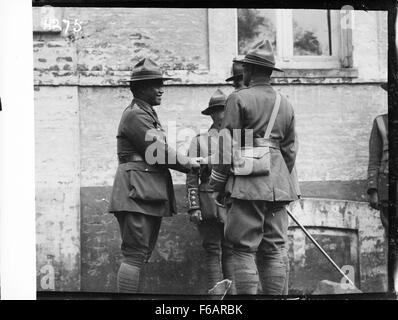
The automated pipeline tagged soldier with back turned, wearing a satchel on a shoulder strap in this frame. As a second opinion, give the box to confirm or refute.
[209,41,298,295]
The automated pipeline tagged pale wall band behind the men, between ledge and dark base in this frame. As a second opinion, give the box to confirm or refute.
[79,84,387,186]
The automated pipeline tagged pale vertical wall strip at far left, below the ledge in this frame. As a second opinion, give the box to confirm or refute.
[35,87,80,291]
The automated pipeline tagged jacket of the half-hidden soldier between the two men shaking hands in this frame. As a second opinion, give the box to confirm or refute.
[186,126,218,217]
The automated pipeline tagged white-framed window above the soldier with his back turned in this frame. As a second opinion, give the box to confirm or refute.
[237,8,341,68]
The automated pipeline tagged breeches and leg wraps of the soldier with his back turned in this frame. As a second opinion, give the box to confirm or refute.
[225,198,290,294]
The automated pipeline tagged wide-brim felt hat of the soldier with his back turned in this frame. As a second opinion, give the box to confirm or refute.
[239,40,284,72]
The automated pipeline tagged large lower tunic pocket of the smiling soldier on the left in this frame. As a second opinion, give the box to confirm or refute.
[127,169,168,202]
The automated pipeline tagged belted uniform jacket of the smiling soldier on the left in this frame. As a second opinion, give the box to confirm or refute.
[109,99,190,216]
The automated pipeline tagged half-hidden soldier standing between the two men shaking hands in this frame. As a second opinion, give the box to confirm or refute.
[186,89,234,294]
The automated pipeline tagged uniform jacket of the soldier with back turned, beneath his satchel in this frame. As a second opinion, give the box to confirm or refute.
[210,79,298,201]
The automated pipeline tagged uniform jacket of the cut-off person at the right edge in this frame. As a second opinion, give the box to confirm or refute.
[368,114,388,201]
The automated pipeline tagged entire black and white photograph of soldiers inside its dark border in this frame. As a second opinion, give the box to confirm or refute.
[0,1,398,302]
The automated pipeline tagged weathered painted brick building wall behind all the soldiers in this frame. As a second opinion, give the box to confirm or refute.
[33,8,387,293]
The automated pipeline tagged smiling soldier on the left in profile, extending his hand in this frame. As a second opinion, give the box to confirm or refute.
[109,59,200,293]
